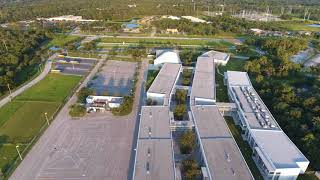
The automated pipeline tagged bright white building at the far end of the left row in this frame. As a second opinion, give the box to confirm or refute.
[153,50,181,66]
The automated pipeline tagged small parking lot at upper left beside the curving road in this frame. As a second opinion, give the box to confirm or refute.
[53,58,97,76]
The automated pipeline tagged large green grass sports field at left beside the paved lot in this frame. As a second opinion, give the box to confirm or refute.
[0,74,81,175]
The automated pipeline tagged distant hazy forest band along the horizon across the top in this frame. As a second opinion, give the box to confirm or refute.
[0,0,320,22]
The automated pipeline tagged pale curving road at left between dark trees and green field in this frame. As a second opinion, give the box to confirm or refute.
[0,54,56,108]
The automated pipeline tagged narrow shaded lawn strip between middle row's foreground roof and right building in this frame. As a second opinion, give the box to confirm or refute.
[225,117,263,180]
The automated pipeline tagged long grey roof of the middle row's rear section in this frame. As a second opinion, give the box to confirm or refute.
[191,56,216,105]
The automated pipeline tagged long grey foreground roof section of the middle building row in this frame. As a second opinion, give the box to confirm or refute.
[191,105,253,180]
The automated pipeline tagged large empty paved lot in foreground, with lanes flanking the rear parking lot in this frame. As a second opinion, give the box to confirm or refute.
[10,57,148,180]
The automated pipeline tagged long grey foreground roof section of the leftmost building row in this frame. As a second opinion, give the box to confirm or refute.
[134,106,175,180]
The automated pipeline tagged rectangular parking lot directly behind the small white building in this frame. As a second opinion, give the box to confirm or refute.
[89,60,137,96]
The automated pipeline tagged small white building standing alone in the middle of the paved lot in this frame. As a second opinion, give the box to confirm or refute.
[86,96,123,112]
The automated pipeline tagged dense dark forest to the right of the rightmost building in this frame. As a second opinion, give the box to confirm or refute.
[245,38,320,170]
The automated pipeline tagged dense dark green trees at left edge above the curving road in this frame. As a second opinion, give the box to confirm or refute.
[0,29,49,96]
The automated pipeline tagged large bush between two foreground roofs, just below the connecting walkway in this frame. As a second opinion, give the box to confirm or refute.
[179,130,196,154]
